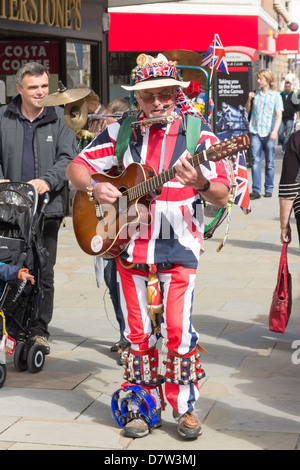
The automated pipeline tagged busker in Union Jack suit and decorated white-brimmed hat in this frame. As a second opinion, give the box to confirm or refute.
[67,54,229,439]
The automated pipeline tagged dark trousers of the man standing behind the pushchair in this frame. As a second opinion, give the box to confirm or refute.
[32,218,62,338]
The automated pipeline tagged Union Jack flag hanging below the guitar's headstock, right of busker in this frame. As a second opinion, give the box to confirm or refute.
[233,150,251,214]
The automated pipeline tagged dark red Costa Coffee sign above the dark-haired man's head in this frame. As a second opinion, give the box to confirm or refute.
[0,41,59,75]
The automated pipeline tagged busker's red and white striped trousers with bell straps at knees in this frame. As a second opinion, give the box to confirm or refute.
[117,259,205,414]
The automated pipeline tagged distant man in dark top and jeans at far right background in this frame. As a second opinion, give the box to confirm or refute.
[278,80,300,152]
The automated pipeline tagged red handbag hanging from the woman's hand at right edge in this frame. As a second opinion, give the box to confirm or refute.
[269,243,292,333]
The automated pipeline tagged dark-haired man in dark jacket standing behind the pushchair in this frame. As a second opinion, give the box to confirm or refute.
[0,62,77,353]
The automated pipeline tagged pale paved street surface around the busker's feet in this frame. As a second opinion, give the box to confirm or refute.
[0,147,300,456]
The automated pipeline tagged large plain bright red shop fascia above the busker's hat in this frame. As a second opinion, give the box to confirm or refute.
[109,12,275,53]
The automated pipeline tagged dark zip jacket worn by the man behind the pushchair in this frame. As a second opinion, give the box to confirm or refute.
[0,95,78,217]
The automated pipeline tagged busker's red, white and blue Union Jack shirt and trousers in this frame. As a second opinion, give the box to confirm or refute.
[74,112,229,414]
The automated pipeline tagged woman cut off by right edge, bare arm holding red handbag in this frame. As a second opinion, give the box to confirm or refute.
[279,131,300,243]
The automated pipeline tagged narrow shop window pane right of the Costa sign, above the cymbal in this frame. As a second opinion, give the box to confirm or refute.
[67,42,91,88]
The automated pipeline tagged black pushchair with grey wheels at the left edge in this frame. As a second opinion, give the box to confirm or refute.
[0,182,49,388]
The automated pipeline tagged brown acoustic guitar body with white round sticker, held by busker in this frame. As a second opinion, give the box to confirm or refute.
[73,163,161,259]
